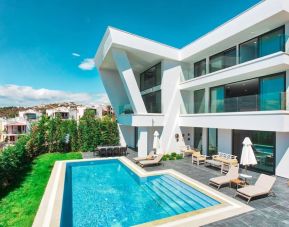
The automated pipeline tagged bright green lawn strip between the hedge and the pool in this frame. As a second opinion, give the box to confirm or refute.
[0,152,81,227]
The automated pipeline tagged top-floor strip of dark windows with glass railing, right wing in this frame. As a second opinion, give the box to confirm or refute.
[181,32,289,82]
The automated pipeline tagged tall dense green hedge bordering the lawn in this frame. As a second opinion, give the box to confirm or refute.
[0,112,119,192]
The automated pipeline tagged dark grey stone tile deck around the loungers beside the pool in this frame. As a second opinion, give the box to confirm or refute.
[83,150,289,227]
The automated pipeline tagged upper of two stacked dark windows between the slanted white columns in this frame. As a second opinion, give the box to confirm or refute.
[140,63,161,91]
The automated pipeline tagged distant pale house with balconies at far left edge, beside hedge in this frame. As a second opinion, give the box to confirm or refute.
[0,118,30,144]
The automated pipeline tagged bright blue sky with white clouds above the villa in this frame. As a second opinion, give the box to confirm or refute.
[0,0,260,106]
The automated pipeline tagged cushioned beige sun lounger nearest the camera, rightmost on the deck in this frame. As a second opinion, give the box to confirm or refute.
[235,174,276,203]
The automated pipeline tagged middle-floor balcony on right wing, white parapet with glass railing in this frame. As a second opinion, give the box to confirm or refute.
[180,92,289,132]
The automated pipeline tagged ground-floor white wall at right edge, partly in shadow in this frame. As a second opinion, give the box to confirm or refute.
[276,132,289,178]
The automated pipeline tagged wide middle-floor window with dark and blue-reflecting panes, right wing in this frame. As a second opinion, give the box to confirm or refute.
[210,72,286,113]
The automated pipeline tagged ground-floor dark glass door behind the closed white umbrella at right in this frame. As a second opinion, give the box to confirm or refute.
[233,130,276,174]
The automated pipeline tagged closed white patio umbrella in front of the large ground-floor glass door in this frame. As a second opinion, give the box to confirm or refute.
[240,137,257,172]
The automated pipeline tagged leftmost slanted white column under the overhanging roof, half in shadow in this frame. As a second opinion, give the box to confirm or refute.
[112,49,147,113]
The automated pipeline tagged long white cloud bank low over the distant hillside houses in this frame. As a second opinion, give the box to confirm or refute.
[0,84,109,106]
